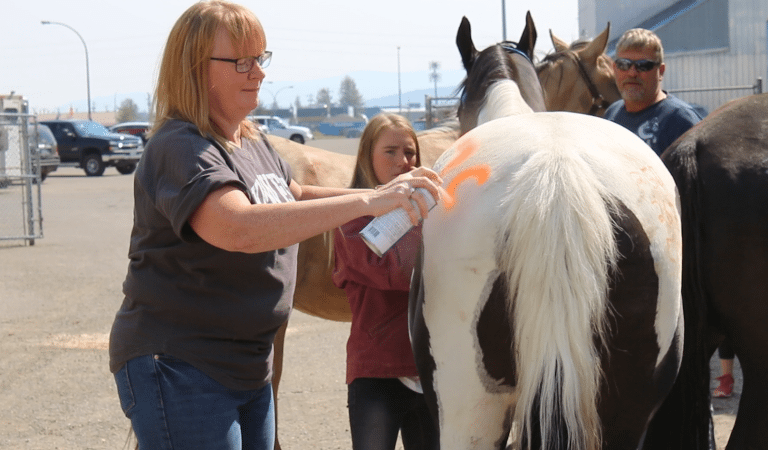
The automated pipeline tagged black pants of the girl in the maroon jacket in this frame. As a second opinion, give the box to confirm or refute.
[347,378,440,450]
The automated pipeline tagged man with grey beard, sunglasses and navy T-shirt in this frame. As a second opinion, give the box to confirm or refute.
[604,28,702,155]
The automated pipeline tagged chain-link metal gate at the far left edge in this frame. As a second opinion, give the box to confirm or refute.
[0,113,43,245]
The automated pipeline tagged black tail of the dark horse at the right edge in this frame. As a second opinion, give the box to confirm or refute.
[645,138,714,450]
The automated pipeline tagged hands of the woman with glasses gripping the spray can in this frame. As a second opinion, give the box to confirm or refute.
[370,167,443,225]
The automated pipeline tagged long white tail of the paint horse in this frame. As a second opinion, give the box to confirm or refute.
[498,149,618,450]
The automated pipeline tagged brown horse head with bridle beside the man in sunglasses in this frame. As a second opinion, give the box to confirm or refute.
[536,23,621,116]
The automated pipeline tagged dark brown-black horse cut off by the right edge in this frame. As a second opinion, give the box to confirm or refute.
[657,94,768,450]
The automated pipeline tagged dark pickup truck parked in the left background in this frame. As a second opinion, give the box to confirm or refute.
[40,120,144,177]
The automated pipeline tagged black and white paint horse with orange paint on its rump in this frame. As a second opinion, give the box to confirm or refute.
[410,14,683,450]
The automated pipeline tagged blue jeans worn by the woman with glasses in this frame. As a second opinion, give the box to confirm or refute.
[115,355,275,450]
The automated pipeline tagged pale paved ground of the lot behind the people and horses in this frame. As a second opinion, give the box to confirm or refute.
[0,139,740,450]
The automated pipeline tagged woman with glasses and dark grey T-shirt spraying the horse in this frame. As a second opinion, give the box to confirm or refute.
[109,1,439,450]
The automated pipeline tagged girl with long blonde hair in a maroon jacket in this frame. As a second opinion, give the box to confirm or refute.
[333,114,439,450]
